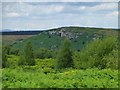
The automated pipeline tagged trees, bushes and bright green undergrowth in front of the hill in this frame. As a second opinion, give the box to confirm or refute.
[2,37,118,88]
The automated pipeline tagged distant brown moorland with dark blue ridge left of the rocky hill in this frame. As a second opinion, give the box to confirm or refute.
[0,30,42,45]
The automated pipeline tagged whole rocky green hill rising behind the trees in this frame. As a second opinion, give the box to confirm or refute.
[3,27,117,50]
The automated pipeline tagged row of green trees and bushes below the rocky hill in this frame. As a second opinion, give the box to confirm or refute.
[2,37,118,69]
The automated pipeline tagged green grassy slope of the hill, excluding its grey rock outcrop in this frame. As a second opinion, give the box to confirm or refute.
[13,27,117,49]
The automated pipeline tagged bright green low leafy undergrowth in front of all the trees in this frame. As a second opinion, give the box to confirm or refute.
[3,66,118,88]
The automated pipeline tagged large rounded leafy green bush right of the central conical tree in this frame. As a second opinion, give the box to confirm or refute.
[73,37,118,69]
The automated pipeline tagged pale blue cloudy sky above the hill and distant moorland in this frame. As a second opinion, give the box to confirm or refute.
[0,0,118,30]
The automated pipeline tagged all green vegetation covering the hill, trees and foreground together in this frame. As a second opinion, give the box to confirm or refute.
[2,27,118,88]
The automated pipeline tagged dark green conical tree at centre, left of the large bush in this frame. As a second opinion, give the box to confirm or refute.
[56,39,73,69]
